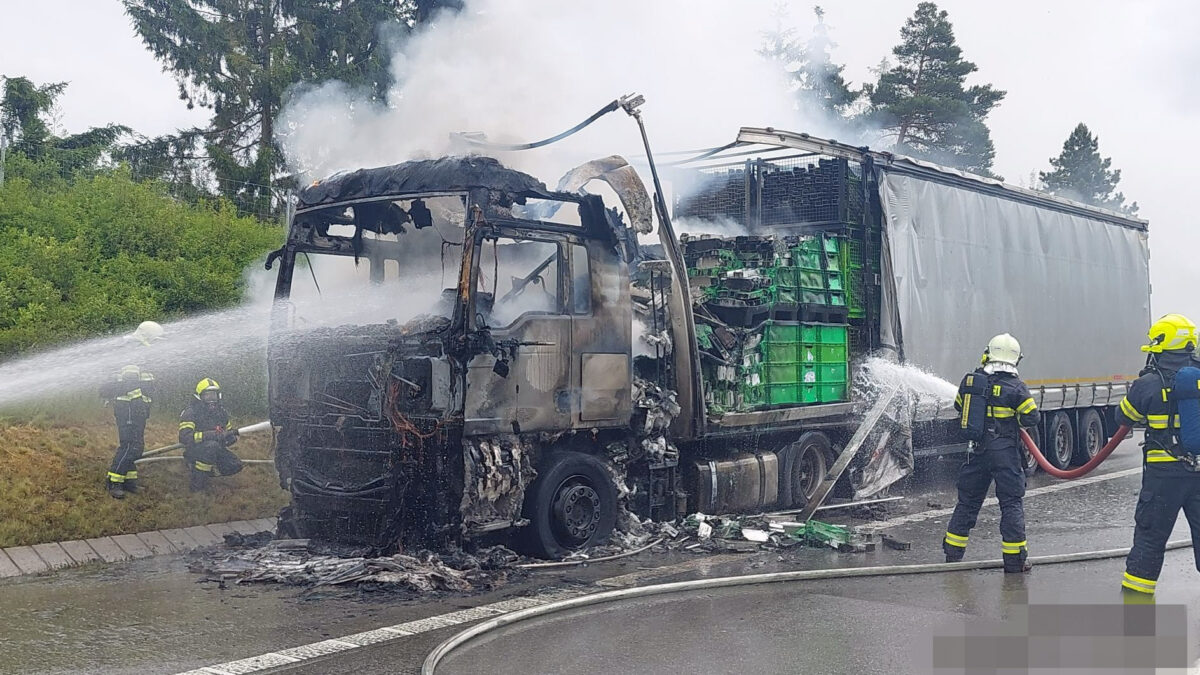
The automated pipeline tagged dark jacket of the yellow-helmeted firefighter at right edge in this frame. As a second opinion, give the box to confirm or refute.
[1117,352,1200,464]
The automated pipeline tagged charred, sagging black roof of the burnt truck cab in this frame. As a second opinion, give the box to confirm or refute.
[296,156,549,209]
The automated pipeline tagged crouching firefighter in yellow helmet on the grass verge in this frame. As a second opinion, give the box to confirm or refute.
[179,377,242,492]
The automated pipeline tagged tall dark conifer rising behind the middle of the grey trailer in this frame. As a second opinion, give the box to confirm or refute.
[866,2,1006,175]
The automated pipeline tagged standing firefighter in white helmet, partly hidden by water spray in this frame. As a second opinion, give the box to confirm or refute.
[100,321,163,500]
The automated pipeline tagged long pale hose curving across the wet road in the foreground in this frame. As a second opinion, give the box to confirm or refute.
[421,535,1192,675]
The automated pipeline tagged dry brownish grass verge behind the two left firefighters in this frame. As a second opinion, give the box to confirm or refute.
[0,413,288,548]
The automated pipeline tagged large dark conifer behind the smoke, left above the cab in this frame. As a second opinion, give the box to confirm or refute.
[122,0,415,213]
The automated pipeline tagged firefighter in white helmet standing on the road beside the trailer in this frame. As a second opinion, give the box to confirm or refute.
[942,333,1042,574]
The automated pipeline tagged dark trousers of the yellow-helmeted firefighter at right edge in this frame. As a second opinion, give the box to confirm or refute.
[1121,462,1200,593]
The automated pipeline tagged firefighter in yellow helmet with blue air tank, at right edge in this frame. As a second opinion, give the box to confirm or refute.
[1117,313,1200,601]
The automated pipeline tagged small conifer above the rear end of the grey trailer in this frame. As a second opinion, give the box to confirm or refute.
[1038,123,1138,215]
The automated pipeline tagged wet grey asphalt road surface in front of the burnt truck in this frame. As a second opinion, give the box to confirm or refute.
[0,432,1200,674]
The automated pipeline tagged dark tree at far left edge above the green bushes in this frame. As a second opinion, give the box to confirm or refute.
[0,77,130,175]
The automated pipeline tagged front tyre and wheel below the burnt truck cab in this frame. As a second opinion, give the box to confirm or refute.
[522,452,617,560]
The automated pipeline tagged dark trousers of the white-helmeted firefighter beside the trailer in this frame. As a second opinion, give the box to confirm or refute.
[942,444,1028,572]
